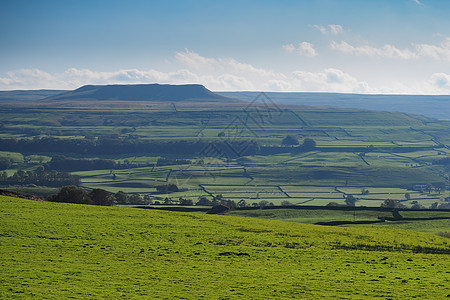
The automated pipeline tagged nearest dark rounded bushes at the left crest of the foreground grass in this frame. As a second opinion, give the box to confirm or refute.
[47,185,114,206]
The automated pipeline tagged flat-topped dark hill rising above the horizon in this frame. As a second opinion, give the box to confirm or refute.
[45,84,239,102]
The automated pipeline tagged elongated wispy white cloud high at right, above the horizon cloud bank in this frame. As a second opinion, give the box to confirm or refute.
[330,41,418,59]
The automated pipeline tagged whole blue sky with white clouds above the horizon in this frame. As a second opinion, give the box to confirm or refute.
[0,0,450,95]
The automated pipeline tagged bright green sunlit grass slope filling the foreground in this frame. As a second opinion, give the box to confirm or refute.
[0,197,450,299]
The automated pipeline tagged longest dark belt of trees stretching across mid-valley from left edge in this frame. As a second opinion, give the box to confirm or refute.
[0,137,259,157]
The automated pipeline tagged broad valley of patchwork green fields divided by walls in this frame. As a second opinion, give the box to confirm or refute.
[0,99,450,207]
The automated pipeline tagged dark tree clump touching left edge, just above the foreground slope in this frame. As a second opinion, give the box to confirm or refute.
[0,167,80,187]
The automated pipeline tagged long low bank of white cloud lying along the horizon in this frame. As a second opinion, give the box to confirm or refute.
[0,47,450,94]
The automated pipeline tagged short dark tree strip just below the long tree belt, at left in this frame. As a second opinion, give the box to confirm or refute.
[46,155,116,172]
